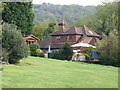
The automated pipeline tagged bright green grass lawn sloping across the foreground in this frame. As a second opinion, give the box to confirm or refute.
[2,57,118,88]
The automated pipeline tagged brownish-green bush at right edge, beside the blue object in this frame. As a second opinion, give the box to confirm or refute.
[97,32,120,66]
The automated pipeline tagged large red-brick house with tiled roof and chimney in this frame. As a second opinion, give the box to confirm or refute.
[40,20,100,52]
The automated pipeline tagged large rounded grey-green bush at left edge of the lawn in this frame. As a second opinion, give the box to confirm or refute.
[2,23,29,64]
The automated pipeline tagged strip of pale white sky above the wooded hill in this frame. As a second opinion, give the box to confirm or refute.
[33,0,113,6]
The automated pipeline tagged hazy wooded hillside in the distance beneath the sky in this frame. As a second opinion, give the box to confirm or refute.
[33,3,96,24]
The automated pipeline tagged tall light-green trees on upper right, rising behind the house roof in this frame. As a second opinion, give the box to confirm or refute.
[77,2,118,35]
